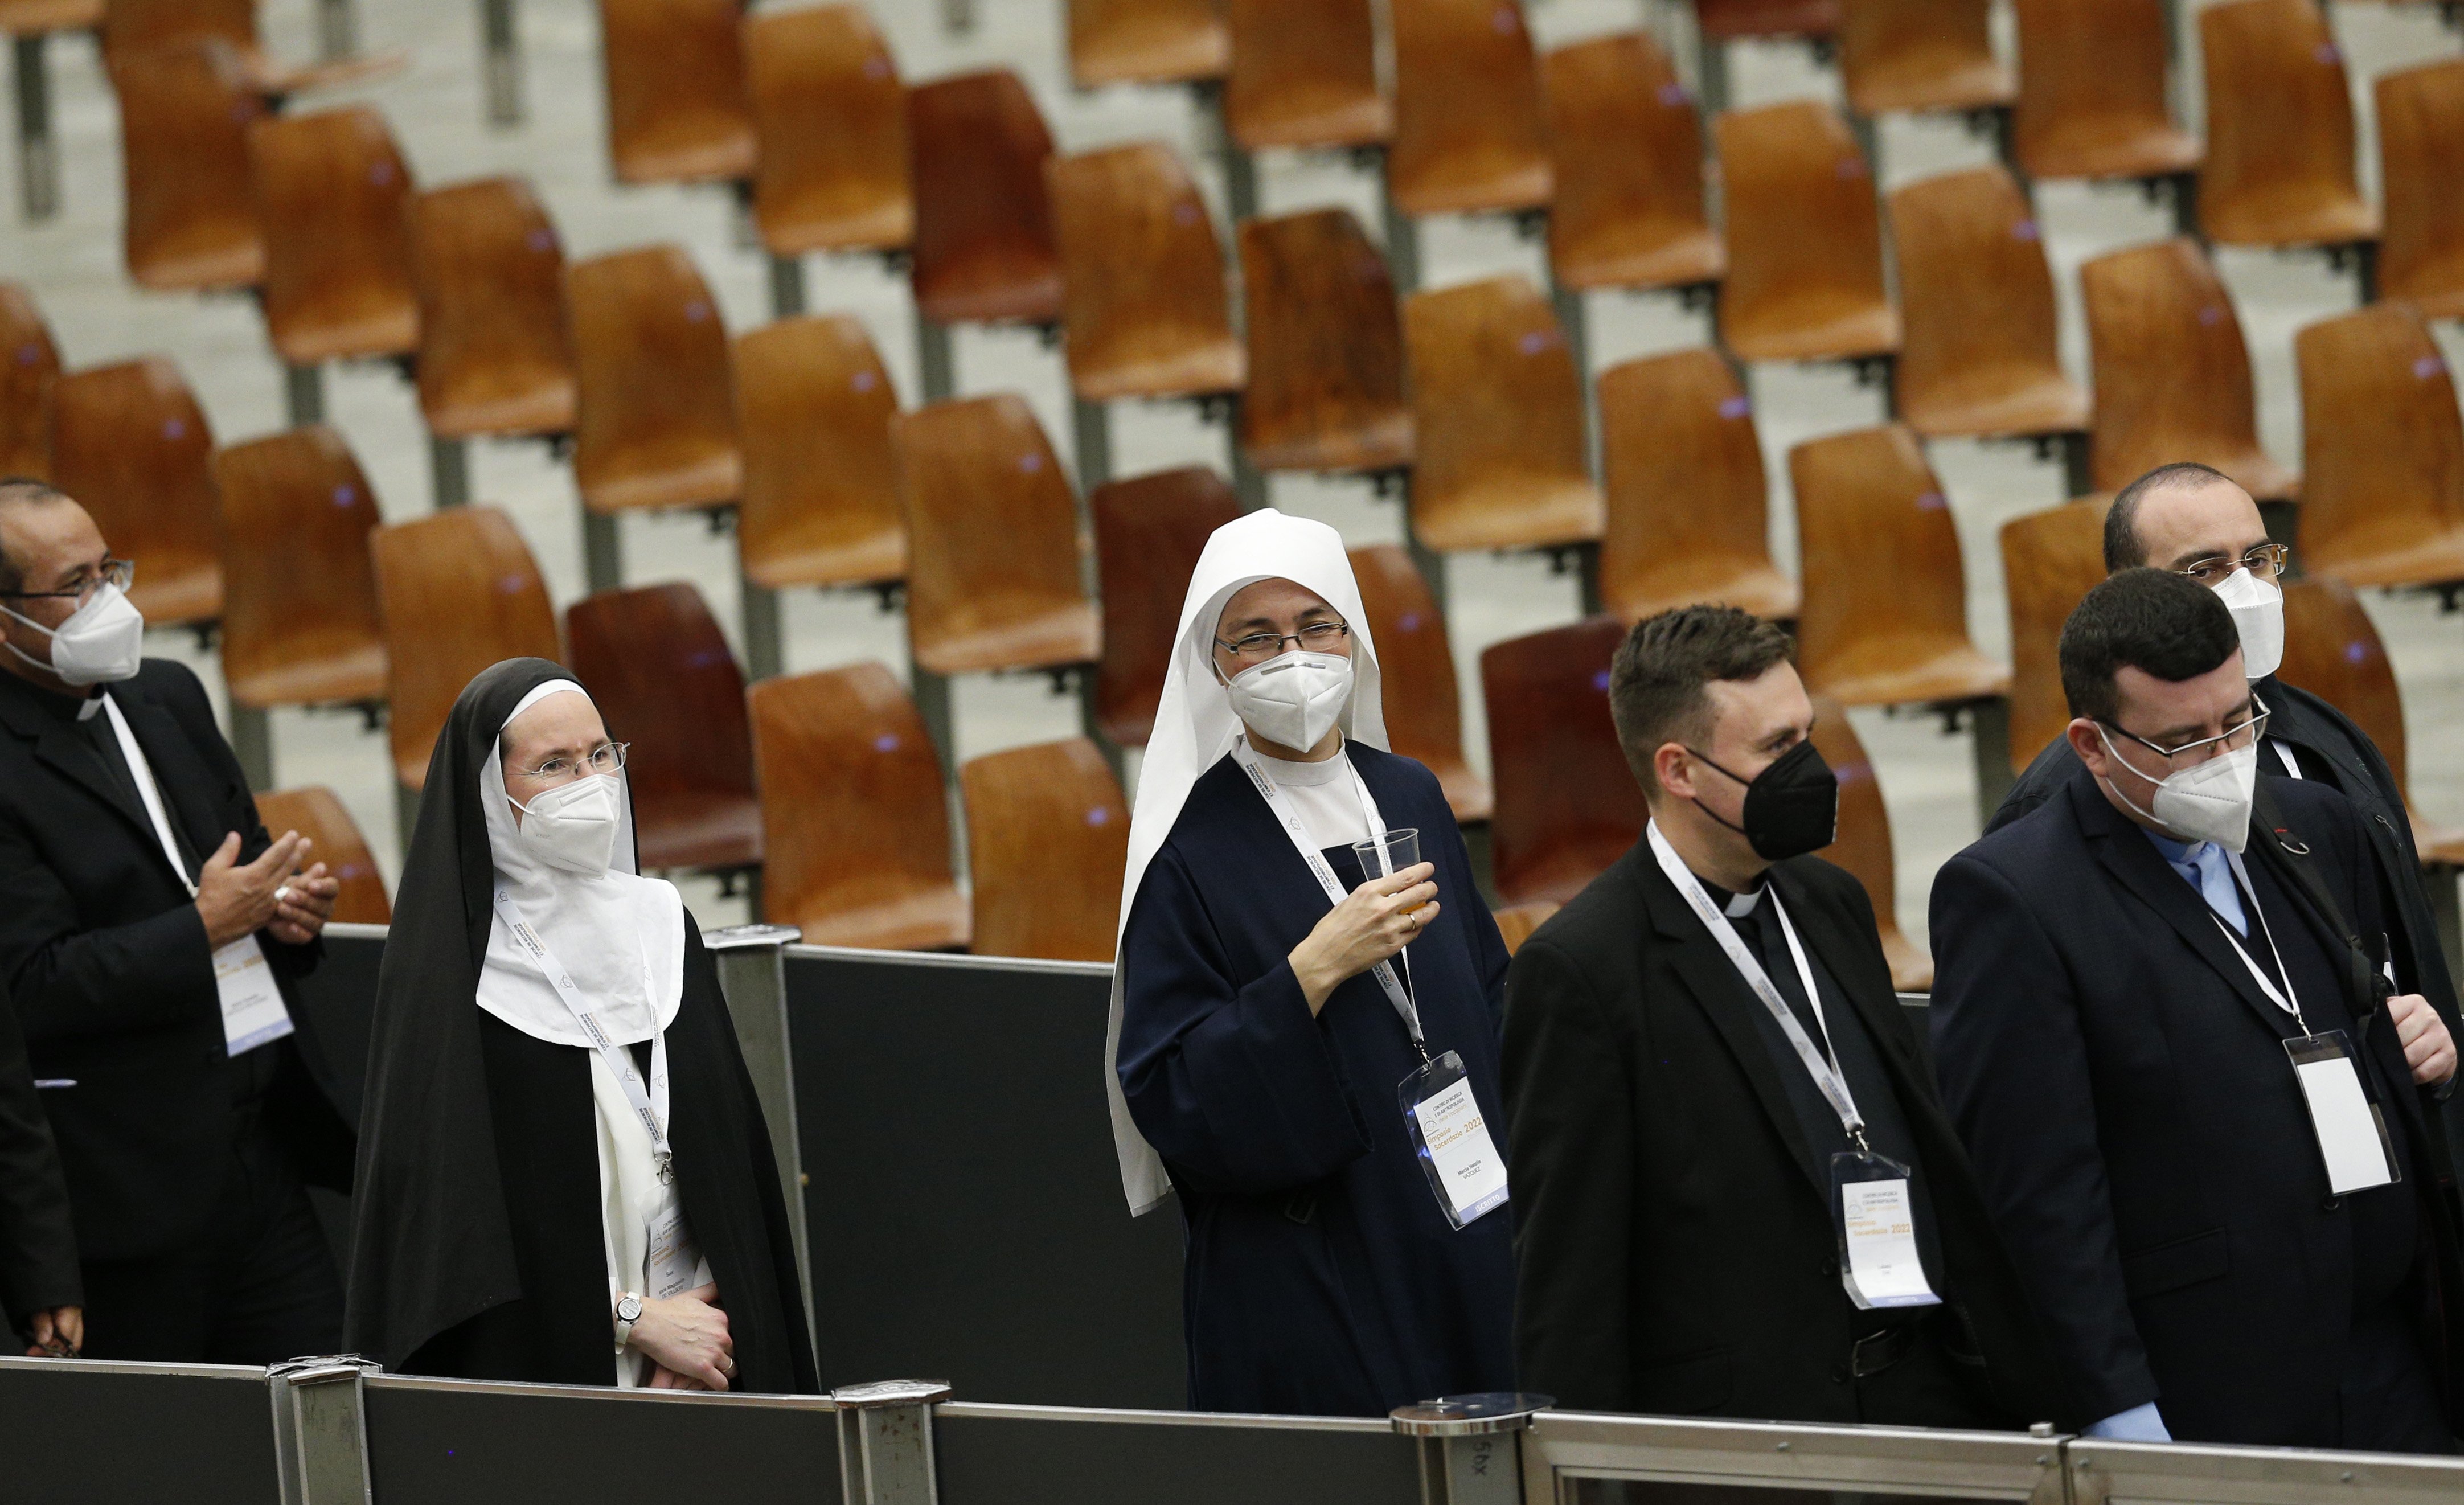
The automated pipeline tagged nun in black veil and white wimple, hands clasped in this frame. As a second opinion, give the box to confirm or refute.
[345,658,818,1392]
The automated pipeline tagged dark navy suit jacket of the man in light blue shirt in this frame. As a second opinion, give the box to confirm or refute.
[1932,769,2454,1446]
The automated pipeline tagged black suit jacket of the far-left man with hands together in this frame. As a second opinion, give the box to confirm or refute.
[0,660,352,1258]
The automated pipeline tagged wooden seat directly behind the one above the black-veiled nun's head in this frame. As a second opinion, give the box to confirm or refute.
[412,177,574,438]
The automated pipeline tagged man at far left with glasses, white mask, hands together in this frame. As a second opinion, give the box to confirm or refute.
[0,481,352,1364]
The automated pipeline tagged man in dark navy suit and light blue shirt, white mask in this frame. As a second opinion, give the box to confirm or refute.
[1932,569,2464,1453]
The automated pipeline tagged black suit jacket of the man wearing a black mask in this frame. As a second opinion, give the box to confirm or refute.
[1506,835,2077,1424]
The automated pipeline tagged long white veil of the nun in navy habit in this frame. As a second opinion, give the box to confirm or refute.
[1104,507,1387,1215]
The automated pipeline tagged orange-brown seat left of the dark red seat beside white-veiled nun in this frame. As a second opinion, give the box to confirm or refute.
[889,392,1104,675]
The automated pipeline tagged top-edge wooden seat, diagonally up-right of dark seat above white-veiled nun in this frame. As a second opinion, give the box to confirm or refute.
[1387,0,1552,217]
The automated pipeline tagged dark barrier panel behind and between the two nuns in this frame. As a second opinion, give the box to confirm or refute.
[786,946,1188,1409]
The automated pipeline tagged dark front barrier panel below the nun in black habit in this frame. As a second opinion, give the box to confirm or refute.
[362,1377,841,1505]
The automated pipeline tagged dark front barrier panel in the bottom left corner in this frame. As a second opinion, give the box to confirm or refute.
[0,1357,276,1505]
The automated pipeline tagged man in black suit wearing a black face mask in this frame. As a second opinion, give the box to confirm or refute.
[1506,606,2072,1429]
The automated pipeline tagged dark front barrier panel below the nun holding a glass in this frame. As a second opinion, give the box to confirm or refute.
[934,1401,1419,1505]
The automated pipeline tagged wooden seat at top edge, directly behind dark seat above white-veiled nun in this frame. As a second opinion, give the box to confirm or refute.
[1225,0,1395,153]
